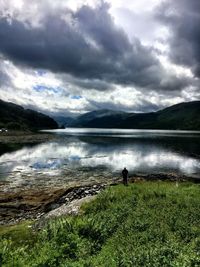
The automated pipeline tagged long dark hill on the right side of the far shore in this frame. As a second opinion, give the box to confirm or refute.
[69,101,200,130]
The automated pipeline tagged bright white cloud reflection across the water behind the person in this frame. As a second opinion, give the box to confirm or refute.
[0,138,200,181]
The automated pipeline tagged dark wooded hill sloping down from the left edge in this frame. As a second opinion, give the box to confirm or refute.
[0,100,58,130]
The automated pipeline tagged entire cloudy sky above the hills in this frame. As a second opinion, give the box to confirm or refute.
[0,0,200,116]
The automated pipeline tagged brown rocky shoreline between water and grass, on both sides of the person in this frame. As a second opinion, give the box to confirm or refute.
[0,173,200,225]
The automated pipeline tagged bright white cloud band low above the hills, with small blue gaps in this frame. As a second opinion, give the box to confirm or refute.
[0,55,199,115]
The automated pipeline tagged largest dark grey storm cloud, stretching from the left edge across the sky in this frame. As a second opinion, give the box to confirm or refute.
[0,3,188,90]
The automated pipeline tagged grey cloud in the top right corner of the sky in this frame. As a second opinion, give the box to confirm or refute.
[157,0,200,77]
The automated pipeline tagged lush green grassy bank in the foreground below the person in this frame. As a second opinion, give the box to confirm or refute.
[0,182,200,267]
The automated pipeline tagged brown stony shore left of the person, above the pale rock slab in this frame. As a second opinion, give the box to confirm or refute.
[0,184,108,225]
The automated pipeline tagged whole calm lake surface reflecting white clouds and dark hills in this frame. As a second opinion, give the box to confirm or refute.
[0,128,200,189]
